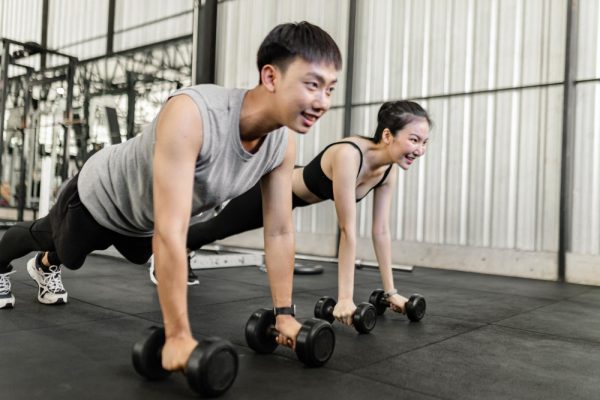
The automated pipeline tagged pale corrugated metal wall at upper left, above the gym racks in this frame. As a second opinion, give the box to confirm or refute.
[0,0,194,65]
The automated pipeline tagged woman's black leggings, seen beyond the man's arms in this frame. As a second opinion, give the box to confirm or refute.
[187,182,308,250]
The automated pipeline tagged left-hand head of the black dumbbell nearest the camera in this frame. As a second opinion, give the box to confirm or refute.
[131,327,171,381]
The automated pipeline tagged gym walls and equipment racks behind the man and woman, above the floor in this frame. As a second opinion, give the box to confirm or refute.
[0,0,600,285]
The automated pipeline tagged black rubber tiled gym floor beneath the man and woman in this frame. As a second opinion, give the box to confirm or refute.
[0,250,600,400]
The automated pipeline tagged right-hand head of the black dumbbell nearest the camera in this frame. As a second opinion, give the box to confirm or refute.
[185,337,238,397]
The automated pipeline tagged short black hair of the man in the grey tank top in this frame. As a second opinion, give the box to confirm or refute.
[256,21,342,83]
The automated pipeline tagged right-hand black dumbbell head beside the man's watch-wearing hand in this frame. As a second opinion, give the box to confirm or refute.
[296,318,335,367]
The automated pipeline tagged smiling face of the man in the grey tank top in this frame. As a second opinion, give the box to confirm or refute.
[274,57,337,133]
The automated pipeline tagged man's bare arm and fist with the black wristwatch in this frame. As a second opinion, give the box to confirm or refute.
[261,131,300,347]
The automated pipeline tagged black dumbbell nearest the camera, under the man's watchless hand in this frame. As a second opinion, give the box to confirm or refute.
[131,327,238,397]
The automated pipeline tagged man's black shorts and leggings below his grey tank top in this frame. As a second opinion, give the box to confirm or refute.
[0,176,152,273]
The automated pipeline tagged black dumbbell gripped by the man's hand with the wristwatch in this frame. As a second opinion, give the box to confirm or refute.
[246,308,335,367]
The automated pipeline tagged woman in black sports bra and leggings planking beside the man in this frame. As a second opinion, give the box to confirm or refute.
[164,101,431,325]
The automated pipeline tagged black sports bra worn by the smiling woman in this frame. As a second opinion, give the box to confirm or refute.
[302,141,394,203]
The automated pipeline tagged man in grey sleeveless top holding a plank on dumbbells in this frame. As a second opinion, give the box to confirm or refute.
[0,22,341,370]
